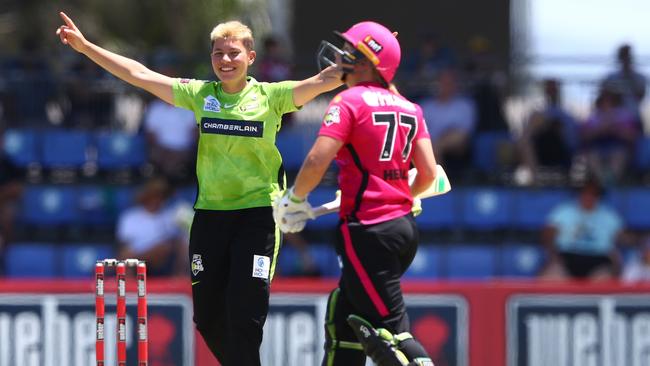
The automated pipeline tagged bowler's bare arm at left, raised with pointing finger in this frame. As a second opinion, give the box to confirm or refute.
[56,12,174,104]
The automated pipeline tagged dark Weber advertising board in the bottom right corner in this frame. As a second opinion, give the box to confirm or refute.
[507,294,650,366]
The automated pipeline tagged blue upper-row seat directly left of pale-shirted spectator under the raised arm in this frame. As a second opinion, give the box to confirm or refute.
[95,132,147,170]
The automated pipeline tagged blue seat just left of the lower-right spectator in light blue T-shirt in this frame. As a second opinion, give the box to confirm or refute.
[513,189,571,230]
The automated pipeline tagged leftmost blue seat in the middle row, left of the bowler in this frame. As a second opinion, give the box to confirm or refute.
[21,186,79,225]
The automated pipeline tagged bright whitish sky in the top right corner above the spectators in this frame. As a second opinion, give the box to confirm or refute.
[528,0,650,121]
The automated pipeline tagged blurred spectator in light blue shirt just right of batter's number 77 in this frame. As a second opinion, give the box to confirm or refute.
[421,69,476,171]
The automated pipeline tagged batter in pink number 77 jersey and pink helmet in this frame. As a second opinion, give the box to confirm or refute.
[275,22,436,366]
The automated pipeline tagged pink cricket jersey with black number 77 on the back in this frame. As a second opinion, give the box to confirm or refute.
[318,83,429,225]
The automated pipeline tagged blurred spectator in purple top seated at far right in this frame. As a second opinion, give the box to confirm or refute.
[580,89,641,185]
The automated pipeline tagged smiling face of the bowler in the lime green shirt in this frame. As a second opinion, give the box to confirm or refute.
[211,37,255,93]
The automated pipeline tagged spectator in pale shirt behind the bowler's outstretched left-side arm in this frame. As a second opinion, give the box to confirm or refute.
[144,58,199,185]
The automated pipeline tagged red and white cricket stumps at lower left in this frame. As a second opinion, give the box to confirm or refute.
[95,259,148,366]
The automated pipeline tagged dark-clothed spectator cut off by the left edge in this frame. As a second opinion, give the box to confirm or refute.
[0,130,23,274]
